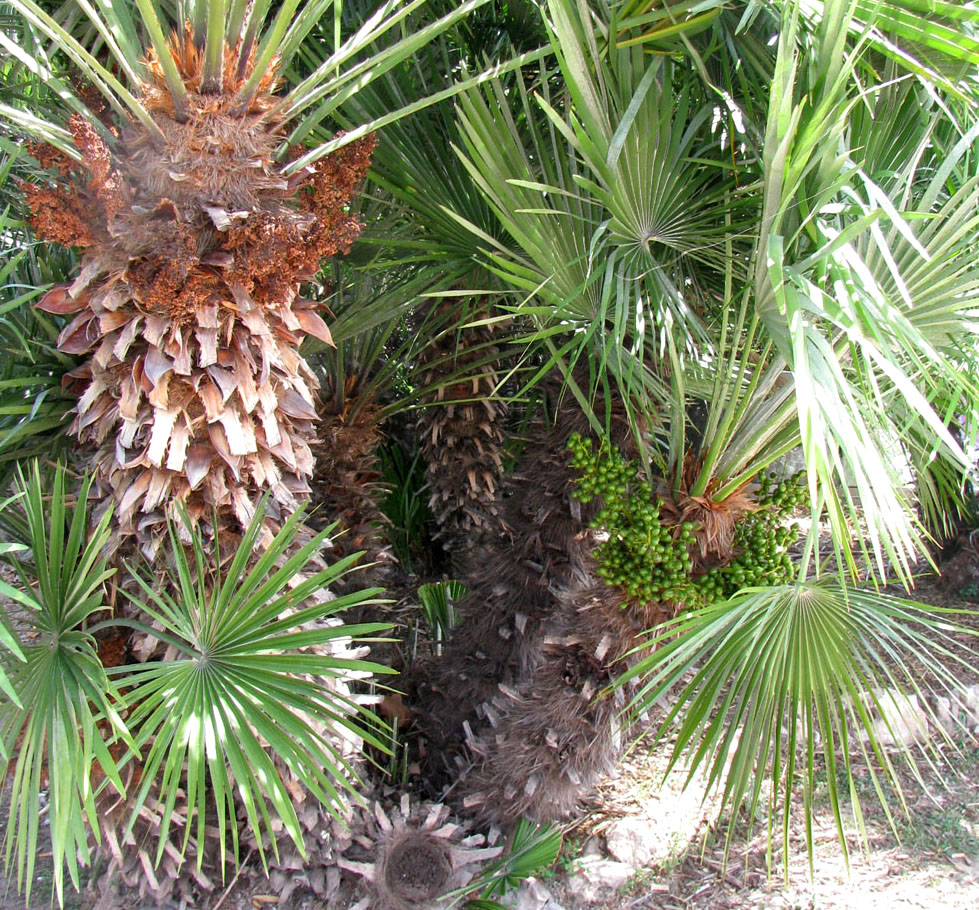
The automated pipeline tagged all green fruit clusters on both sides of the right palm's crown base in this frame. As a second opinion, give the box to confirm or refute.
[568,433,806,606]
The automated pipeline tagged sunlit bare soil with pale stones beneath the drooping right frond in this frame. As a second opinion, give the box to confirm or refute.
[544,720,979,910]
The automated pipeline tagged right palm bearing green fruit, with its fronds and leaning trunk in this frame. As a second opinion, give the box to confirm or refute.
[432,0,979,868]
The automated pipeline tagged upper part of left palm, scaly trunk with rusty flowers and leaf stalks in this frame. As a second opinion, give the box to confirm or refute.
[0,0,490,554]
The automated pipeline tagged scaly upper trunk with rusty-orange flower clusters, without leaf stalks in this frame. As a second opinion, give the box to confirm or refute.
[27,32,374,555]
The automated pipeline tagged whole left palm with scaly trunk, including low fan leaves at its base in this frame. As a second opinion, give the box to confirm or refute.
[0,0,528,896]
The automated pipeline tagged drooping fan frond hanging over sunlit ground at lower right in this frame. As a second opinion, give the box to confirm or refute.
[617,583,975,876]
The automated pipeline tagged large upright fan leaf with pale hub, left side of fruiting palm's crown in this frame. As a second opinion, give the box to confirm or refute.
[458,2,764,452]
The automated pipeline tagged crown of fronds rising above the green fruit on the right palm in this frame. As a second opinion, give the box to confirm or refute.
[459,2,977,580]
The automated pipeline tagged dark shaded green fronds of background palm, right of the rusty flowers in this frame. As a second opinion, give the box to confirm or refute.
[303,30,528,416]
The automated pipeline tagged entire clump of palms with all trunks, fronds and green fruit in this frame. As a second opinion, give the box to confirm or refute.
[0,0,979,899]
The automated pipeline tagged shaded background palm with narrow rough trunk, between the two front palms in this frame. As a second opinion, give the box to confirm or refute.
[292,12,547,563]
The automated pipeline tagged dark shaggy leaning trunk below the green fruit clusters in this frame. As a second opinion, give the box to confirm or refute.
[406,382,662,824]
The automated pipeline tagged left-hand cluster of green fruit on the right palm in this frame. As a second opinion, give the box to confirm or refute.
[568,433,696,603]
